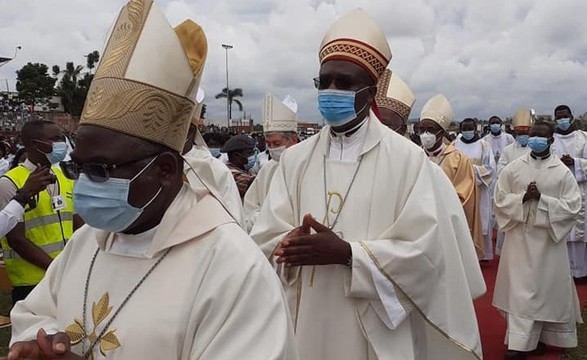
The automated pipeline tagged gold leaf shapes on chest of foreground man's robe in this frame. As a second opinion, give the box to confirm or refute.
[65,292,121,360]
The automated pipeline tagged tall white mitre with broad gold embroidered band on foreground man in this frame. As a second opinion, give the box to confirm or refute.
[80,0,208,152]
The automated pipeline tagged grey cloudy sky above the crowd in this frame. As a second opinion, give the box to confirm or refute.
[0,0,587,121]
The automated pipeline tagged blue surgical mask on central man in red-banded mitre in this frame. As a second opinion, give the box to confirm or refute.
[318,87,369,126]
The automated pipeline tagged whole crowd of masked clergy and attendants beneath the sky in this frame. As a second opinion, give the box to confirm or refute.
[0,0,587,360]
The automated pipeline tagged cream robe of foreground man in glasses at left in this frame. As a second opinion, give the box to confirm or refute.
[11,185,298,360]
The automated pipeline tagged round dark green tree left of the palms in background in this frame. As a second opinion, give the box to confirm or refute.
[16,63,56,106]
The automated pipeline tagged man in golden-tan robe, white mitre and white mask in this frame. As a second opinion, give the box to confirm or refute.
[418,94,484,258]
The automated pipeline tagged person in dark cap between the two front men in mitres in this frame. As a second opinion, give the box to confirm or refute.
[220,135,259,199]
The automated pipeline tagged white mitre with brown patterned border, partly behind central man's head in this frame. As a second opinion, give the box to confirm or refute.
[375,69,416,121]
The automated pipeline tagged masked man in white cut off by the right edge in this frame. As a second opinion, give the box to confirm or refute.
[552,105,587,278]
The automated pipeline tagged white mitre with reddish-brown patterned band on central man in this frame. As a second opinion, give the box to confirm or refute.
[319,9,391,80]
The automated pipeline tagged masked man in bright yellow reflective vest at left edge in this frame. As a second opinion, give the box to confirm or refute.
[0,120,83,303]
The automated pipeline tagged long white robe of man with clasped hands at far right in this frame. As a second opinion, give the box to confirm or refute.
[493,154,581,323]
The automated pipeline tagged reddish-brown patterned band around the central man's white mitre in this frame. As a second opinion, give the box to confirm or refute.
[320,39,389,79]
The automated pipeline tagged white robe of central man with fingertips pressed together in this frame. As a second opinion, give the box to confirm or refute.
[251,112,485,360]
